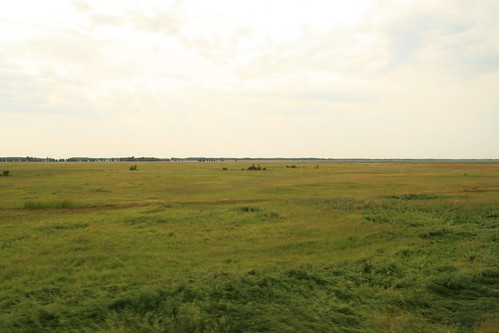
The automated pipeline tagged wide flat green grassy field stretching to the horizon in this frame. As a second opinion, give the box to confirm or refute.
[0,161,499,332]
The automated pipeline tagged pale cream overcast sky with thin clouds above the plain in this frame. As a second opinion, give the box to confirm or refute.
[0,0,499,158]
